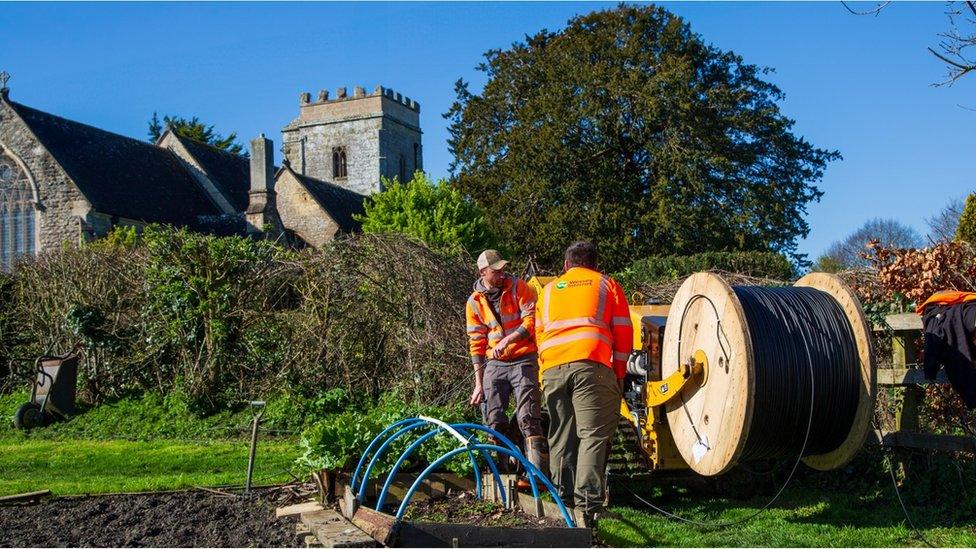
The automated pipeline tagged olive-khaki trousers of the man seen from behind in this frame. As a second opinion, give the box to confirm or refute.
[542,361,620,515]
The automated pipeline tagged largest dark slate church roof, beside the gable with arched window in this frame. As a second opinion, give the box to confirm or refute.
[9,101,221,227]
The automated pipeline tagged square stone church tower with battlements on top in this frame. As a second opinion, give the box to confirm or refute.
[281,86,423,195]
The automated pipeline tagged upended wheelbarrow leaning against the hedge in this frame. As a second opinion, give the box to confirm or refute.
[14,347,79,430]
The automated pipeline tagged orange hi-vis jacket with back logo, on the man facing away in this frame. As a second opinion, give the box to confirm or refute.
[535,267,634,379]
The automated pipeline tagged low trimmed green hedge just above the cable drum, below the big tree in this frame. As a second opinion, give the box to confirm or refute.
[615,252,796,291]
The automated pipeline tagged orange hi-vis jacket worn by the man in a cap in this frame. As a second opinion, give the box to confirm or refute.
[464,276,536,364]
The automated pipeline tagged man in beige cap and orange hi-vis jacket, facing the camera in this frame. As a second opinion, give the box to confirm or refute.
[465,250,549,475]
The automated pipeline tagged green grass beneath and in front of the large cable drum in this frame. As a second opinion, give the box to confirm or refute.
[598,476,976,547]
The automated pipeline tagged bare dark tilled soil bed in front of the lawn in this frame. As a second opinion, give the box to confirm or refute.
[0,491,304,547]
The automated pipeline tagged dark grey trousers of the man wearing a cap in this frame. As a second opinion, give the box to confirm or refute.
[482,354,543,438]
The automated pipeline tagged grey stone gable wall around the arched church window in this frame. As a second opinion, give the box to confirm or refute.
[0,98,91,252]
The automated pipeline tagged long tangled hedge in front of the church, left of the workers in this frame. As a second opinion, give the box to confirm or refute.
[0,227,472,413]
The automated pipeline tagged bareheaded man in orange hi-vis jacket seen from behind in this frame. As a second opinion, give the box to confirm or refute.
[535,241,634,525]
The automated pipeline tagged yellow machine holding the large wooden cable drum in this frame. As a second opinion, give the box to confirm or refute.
[528,276,707,470]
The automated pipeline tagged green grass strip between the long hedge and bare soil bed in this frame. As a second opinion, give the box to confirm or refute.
[0,393,303,496]
